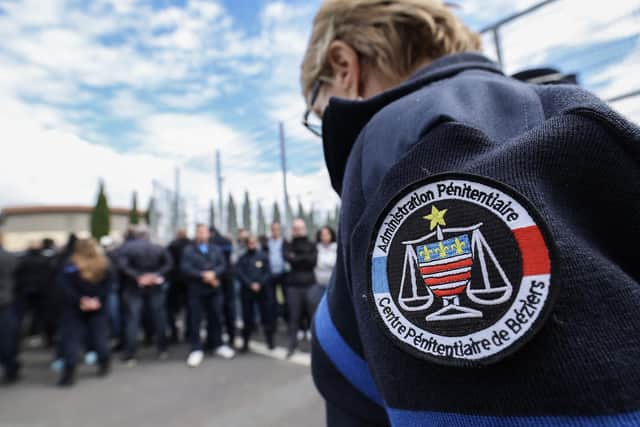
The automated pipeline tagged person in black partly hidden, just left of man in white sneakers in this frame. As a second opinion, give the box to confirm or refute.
[167,228,191,343]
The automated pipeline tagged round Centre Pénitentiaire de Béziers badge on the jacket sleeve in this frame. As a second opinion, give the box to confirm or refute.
[369,173,556,366]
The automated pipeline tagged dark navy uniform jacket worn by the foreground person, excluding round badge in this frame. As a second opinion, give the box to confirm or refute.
[312,54,640,426]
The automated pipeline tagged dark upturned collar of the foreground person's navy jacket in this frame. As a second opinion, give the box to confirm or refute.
[322,53,502,194]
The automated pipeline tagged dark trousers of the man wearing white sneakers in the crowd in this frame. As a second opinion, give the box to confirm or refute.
[188,290,223,351]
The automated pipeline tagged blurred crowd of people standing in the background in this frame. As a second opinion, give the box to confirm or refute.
[0,219,336,386]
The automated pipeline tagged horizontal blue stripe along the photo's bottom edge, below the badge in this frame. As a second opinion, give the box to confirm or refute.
[387,408,640,427]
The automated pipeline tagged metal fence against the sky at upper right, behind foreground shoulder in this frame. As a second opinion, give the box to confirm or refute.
[480,0,640,123]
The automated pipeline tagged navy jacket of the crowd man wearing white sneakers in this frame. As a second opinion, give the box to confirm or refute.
[180,243,227,295]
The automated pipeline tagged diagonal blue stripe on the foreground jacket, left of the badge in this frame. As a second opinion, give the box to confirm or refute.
[315,295,383,406]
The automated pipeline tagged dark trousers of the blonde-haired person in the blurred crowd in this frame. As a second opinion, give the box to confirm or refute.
[60,309,110,369]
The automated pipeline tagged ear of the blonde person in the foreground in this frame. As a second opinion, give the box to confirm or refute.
[328,40,362,99]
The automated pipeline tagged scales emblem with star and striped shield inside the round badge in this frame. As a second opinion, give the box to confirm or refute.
[398,205,513,322]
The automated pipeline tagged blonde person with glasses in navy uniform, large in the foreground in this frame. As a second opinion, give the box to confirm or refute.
[301,0,640,426]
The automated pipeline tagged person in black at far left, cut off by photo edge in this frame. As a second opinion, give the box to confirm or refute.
[0,234,20,384]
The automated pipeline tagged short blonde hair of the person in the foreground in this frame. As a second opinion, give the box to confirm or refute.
[301,0,481,99]
